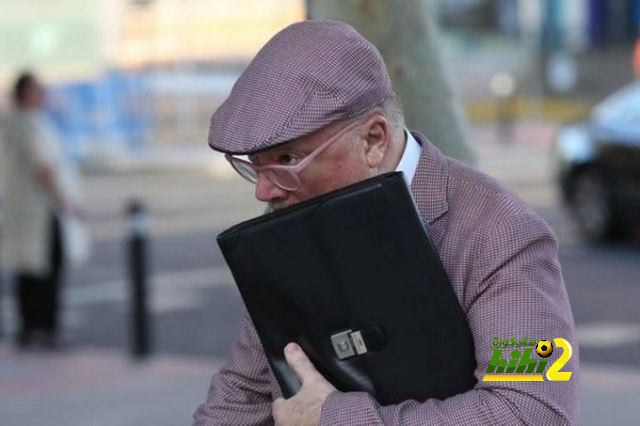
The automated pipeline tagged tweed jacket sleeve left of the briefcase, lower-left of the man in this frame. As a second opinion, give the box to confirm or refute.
[193,311,273,426]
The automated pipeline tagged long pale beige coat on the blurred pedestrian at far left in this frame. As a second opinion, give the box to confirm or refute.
[0,110,88,275]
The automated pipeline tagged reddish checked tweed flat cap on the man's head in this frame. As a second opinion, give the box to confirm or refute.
[209,20,392,154]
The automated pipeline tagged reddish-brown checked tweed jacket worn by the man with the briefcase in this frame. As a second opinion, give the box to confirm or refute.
[194,134,579,426]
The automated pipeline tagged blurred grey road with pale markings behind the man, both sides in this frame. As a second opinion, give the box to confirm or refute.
[2,126,640,367]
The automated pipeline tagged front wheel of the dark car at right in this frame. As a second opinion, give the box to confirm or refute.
[570,170,616,241]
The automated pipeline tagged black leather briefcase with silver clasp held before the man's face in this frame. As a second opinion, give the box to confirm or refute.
[217,172,476,405]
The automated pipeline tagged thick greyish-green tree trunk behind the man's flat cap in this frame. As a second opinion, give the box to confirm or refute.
[306,0,476,165]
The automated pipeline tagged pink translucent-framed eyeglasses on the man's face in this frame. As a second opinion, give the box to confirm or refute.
[224,120,366,191]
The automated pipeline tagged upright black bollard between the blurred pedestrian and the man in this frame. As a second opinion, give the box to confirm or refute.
[128,200,151,359]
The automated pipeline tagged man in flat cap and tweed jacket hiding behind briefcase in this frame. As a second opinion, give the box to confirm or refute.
[194,21,578,426]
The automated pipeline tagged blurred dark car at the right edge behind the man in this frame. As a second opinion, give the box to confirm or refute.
[555,82,640,241]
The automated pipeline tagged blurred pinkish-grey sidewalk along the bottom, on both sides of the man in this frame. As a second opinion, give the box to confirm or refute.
[0,343,640,426]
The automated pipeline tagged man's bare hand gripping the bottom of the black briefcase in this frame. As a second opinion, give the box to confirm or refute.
[273,343,335,426]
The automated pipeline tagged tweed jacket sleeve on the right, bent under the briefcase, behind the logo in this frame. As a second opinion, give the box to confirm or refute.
[320,213,579,426]
